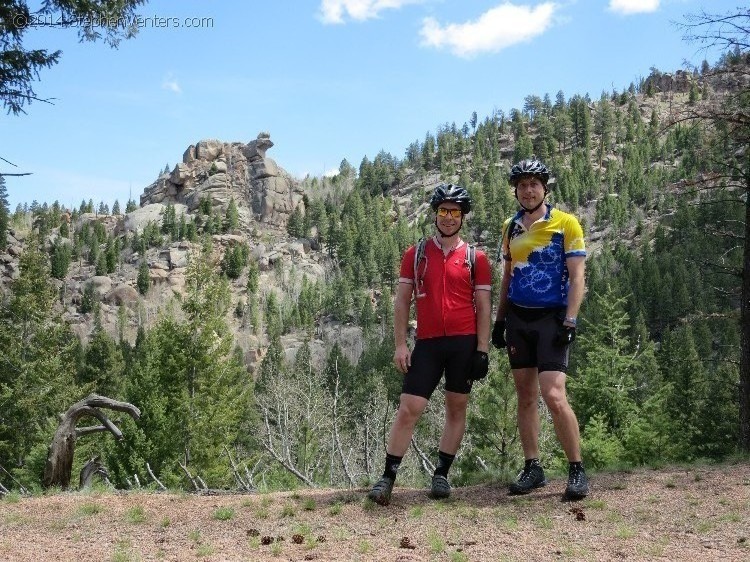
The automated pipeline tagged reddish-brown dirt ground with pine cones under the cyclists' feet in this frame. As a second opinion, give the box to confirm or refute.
[0,463,750,562]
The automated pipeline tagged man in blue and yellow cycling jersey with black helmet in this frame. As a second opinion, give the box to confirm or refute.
[492,159,589,500]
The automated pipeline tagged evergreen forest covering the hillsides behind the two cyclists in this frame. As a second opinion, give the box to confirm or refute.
[0,13,750,494]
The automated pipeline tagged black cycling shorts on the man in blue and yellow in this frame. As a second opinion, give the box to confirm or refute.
[505,303,570,373]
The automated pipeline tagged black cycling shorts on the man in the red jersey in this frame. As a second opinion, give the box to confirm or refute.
[401,334,477,400]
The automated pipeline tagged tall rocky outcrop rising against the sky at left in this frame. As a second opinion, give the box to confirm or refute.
[141,133,302,227]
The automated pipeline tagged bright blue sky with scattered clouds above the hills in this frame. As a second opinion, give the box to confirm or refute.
[0,0,737,210]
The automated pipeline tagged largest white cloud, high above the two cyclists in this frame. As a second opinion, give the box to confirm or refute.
[419,2,557,58]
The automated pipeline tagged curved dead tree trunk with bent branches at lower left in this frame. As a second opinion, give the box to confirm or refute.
[42,394,141,489]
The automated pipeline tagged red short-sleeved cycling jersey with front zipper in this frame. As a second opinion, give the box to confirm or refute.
[398,237,492,339]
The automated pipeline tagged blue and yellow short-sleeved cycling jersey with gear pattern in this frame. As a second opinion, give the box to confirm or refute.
[501,205,586,307]
